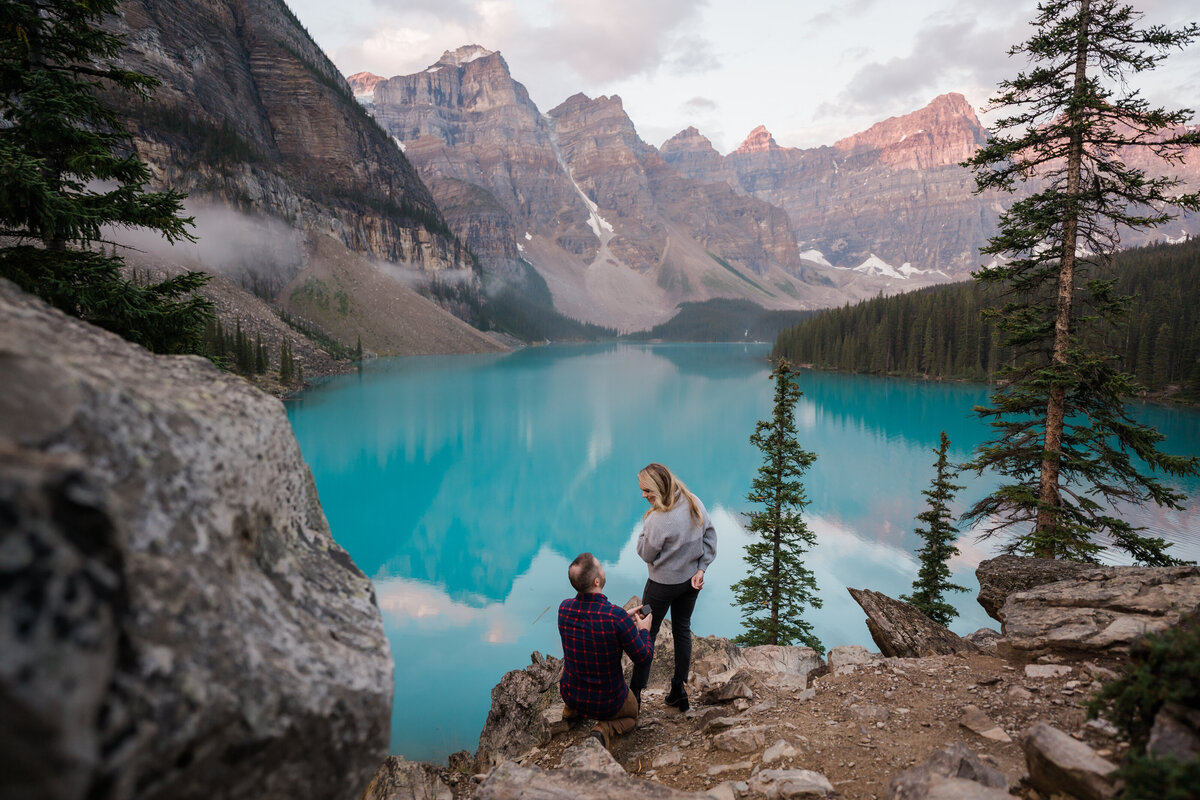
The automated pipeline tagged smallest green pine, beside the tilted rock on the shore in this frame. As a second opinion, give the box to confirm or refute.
[900,431,967,625]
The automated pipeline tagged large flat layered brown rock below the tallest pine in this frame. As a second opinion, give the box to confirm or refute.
[997,566,1200,661]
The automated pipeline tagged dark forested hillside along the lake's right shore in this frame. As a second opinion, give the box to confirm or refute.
[773,239,1200,401]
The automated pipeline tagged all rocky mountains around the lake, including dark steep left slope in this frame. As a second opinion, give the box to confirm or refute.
[105,0,1200,345]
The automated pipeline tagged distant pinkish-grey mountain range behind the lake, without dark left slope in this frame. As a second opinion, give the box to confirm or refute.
[349,44,1200,330]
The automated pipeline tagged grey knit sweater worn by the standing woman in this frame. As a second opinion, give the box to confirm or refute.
[637,497,716,584]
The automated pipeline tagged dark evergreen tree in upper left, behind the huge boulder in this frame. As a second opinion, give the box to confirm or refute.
[0,0,212,353]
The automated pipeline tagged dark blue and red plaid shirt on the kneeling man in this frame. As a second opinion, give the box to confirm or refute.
[558,593,654,720]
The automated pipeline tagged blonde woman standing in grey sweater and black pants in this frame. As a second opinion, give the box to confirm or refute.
[629,464,716,711]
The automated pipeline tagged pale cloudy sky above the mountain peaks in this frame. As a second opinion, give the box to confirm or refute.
[287,0,1200,152]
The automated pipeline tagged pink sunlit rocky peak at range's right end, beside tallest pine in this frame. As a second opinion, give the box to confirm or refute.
[833,92,986,169]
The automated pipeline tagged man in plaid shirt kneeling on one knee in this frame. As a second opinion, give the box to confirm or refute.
[558,553,654,748]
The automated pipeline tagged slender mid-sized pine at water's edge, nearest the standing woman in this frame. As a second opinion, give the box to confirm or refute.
[732,361,824,652]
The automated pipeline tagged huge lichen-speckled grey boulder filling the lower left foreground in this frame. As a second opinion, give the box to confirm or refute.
[0,281,392,800]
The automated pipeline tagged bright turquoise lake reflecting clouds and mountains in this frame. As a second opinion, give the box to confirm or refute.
[288,344,1200,763]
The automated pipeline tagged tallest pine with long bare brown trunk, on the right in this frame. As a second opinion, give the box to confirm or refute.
[965,0,1200,564]
